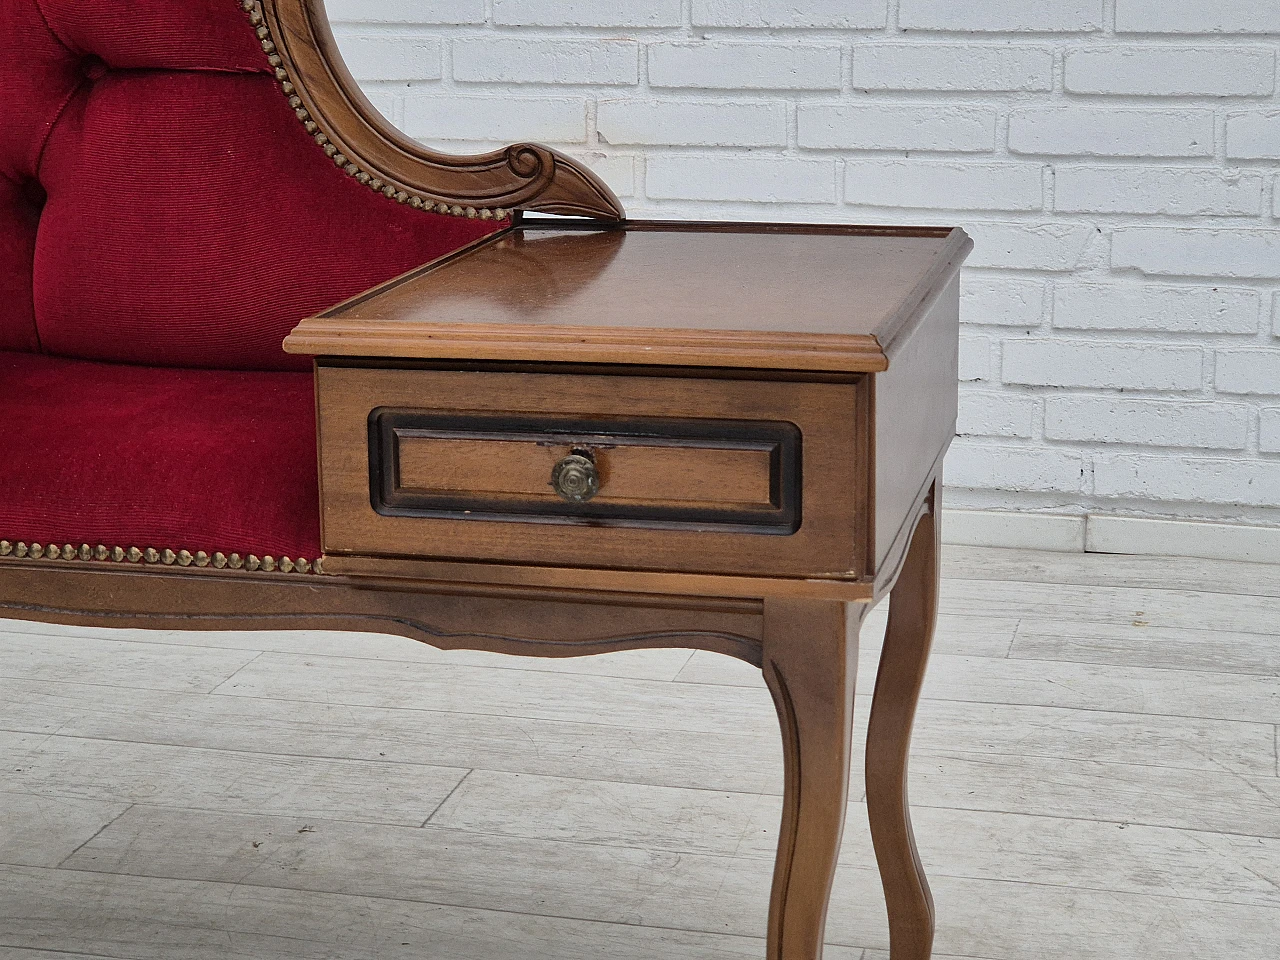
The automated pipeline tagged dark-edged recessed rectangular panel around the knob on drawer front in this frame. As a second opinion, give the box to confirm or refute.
[369,408,801,535]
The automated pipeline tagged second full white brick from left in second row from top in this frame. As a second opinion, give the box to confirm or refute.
[649,42,840,90]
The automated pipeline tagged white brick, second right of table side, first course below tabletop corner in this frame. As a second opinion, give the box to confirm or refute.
[1053,283,1262,334]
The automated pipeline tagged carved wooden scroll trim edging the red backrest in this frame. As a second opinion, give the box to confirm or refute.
[239,0,625,220]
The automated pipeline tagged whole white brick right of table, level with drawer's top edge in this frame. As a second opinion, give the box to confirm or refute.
[1001,339,1203,390]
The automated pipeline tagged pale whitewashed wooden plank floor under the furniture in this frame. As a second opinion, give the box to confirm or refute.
[0,548,1280,960]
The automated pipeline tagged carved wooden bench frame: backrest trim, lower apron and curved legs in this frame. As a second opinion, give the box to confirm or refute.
[0,0,940,960]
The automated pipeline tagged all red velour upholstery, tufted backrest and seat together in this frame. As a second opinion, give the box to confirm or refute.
[0,0,497,559]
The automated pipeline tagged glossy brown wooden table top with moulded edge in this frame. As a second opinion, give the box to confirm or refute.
[285,220,973,371]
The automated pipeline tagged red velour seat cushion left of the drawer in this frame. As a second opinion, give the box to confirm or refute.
[0,352,320,559]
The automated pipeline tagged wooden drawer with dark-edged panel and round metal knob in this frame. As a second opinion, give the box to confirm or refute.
[316,365,868,576]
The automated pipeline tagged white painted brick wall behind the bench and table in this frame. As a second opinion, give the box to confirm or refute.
[326,0,1280,526]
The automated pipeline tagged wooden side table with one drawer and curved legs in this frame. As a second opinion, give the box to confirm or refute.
[285,219,972,960]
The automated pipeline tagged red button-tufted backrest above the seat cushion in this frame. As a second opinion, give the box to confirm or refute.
[0,0,494,370]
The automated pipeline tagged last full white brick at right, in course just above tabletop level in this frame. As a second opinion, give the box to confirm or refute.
[1053,166,1263,216]
